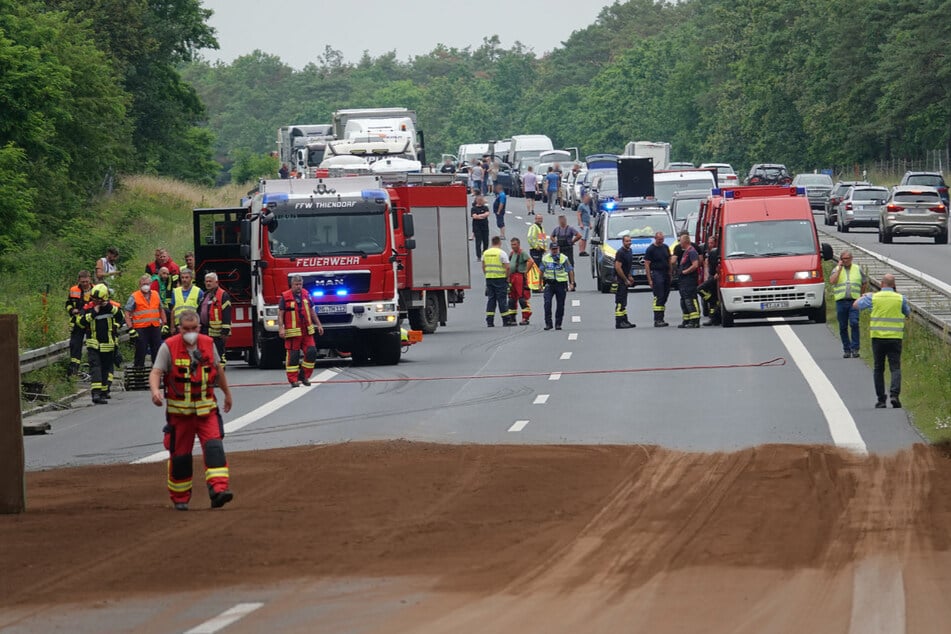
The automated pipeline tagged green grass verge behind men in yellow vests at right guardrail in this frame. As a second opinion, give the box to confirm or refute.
[824,262,951,443]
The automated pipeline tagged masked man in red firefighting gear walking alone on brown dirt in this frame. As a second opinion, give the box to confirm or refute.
[149,309,234,511]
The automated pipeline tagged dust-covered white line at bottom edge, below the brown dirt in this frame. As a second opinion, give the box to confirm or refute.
[849,556,905,634]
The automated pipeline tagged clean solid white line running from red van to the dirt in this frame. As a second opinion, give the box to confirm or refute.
[773,325,868,456]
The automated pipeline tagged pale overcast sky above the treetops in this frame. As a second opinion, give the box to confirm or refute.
[201,0,612,69]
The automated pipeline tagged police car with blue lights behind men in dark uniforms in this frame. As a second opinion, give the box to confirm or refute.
[591,200,676,293]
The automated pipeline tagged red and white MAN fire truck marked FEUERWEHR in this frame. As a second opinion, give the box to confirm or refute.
[193,174,470,368]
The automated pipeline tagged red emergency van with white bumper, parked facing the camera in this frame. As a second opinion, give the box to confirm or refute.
[696,186,832,328]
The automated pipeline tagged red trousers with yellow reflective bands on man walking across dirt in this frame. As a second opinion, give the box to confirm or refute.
[164,409,229,504]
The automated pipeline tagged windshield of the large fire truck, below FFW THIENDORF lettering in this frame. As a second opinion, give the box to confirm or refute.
[268,201,387,257]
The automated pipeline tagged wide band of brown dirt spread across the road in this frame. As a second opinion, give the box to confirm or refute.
[0,441,951,628]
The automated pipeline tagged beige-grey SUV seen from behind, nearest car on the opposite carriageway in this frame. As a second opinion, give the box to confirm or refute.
[878,185,948,244]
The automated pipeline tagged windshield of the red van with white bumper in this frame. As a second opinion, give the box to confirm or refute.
[724,220,816,259]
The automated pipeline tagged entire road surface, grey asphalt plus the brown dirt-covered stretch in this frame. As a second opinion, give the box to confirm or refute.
[0,194,951,633]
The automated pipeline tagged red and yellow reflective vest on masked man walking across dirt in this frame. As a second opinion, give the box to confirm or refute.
[165,334,218,416]
